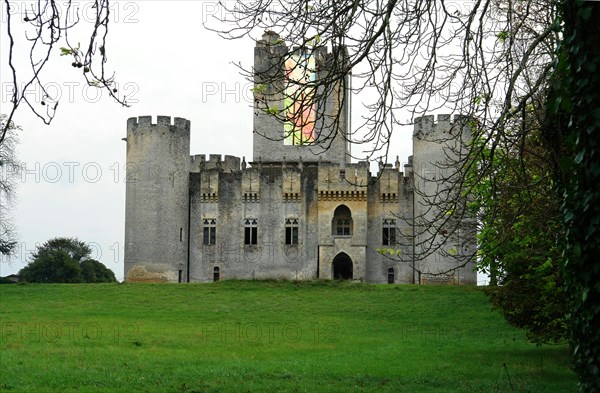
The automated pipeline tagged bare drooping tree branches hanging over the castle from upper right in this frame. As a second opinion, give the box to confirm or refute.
[207,0,557,275]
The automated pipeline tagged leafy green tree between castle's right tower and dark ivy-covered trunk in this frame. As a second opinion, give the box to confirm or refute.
[467,109,566,343]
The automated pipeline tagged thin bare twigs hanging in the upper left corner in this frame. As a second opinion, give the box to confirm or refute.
[0,0,128,145]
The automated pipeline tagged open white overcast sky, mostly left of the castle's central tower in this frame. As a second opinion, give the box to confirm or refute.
[0,1,488,280]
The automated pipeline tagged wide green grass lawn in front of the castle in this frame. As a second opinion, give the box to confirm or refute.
[0,281,577,393]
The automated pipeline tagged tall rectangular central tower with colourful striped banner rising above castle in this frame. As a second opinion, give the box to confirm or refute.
[253,31,351,165]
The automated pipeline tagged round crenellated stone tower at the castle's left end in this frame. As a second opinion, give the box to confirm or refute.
[124,116,190,282]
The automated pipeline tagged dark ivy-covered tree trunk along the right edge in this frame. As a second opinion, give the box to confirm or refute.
[546,0,600,392]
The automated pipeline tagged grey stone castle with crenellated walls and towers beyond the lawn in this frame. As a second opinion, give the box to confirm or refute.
[124,32,476,284]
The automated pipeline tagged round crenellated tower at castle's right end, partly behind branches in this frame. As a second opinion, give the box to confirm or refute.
[413,115,476,283]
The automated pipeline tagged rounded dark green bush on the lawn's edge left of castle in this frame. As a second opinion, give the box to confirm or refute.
[19,237,116,283]
